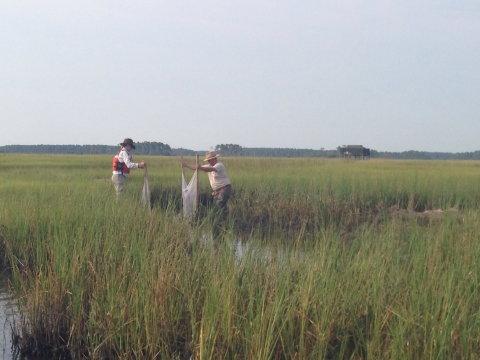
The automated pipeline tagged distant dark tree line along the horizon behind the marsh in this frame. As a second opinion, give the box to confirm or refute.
[0,141,480,160]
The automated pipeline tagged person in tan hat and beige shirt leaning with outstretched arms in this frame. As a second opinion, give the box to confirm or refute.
[182,151,232,215]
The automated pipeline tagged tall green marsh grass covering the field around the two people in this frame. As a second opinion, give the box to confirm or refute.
[0,154,480,359]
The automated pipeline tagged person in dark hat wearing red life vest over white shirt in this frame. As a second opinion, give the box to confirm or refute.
[112,138,147,197]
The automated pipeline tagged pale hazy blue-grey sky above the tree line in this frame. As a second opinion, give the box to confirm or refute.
[0,0,480,152]
